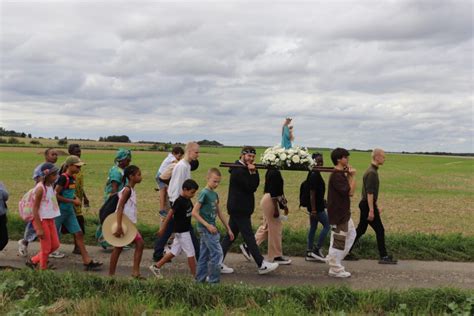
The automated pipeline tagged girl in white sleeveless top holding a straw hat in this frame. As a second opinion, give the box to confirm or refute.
[109,165,145,279]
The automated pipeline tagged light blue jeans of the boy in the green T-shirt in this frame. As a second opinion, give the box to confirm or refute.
[196,227,224,283]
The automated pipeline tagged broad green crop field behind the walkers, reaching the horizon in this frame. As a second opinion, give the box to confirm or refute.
[0,143,474,236]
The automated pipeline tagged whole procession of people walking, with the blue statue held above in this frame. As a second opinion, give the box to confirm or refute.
[0,119,397,283]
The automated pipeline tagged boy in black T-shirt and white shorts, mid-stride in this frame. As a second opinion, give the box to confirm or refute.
[150,179,199,279]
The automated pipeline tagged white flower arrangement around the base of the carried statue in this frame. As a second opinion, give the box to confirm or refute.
[260,145,316,169]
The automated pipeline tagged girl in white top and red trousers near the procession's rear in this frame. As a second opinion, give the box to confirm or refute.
[26,162,60,270]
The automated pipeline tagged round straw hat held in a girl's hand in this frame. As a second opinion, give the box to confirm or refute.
[102,212,138,247]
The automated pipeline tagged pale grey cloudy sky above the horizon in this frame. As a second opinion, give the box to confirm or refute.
[0,0,474,152]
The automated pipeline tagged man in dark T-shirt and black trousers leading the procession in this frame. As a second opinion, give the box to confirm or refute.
[346,148,397,264]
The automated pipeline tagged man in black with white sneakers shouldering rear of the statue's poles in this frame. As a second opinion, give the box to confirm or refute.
[221,146,278,274]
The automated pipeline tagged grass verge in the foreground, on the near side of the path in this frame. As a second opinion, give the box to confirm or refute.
[0,270,474,315]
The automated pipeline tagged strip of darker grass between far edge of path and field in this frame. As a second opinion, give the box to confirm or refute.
[8,215,474,261]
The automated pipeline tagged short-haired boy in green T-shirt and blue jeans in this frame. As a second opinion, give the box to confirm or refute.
[192,168,234,283]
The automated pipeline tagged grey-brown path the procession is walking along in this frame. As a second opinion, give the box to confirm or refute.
[0,240,474,289]
